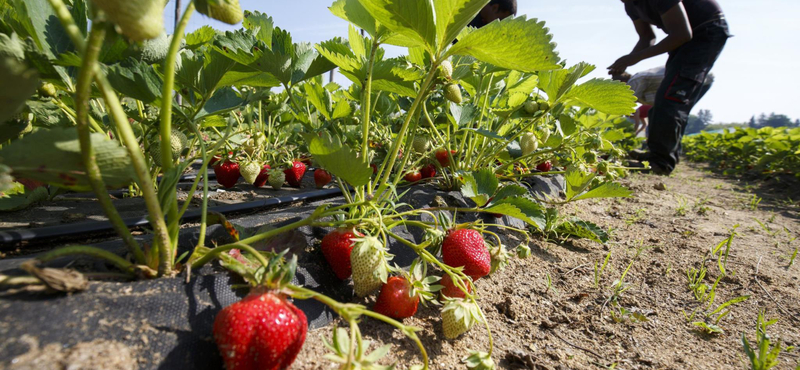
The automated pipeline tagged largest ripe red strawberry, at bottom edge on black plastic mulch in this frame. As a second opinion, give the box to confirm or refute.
[213,288,308,370]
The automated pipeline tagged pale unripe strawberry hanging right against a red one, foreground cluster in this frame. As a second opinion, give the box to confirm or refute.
[350,236,389,297]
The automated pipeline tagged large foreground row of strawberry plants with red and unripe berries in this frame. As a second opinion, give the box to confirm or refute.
[0,0,635,369]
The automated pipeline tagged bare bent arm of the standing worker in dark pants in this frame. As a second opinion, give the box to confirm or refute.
[608,2,692,74]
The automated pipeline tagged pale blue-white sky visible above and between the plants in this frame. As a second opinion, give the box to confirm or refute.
[165,0,800,122]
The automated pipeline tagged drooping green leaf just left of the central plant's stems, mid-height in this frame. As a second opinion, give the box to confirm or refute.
[303,132,372,187]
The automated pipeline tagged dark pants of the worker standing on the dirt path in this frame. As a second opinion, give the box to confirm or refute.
[647,19,730,172]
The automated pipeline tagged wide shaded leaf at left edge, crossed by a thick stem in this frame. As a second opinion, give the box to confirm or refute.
[0,128,133,191]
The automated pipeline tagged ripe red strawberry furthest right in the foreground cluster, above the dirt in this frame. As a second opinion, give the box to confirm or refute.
[442,229,492,280]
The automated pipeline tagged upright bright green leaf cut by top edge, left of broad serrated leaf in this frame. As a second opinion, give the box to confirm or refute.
[435,0,489,47]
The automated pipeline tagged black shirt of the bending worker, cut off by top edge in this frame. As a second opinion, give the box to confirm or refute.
[625,0,722,30]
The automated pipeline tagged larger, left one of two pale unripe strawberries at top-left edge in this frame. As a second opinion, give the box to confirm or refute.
[92,0,167,41]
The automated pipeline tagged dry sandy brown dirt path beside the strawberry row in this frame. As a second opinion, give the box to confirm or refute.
[293,164,800,369]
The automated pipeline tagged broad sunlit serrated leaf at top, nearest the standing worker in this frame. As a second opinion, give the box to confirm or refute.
[447,16,561,72]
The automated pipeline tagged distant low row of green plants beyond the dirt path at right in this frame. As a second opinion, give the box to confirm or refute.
[683,127,800,178]
